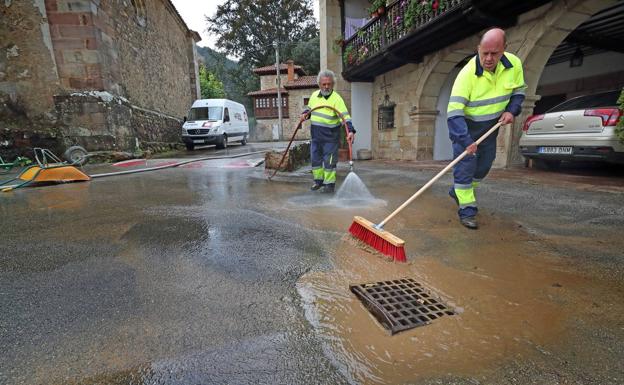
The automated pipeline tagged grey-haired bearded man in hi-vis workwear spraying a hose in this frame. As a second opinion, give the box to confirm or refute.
[301,70,355,193]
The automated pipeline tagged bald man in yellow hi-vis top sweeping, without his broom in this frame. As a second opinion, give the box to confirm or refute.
[447,28,526,229]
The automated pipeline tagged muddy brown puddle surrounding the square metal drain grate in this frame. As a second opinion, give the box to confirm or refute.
[297,190,624,384]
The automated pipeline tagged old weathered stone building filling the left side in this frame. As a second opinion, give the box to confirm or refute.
[0,0,200,157]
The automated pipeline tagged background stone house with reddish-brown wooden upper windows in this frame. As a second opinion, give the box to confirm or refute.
[248,60,318,141]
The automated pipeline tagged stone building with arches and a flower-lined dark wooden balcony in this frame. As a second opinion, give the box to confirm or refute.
[319,0,624,167]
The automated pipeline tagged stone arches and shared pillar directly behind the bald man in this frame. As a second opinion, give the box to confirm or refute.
[409,0,616,167]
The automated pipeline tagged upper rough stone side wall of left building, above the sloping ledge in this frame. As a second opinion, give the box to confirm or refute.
[97,0,197,117]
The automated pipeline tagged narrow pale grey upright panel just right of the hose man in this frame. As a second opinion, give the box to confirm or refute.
[350,83,373,159]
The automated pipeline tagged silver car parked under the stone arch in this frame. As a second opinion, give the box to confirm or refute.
[520,90,624,168]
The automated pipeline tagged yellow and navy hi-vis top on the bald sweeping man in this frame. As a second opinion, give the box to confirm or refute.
[447,52,526,147]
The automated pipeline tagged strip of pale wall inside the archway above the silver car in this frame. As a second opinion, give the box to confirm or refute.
[538,52,624,86]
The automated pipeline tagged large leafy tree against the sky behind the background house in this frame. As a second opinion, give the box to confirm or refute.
[206,0,318,67]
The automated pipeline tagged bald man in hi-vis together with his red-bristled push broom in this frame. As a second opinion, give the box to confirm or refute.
[349,28,526,262]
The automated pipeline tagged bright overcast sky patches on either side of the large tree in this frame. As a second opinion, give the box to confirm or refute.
[171,0,318,48]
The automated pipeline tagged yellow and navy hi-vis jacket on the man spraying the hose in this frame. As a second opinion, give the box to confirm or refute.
[304,90,355,142]
